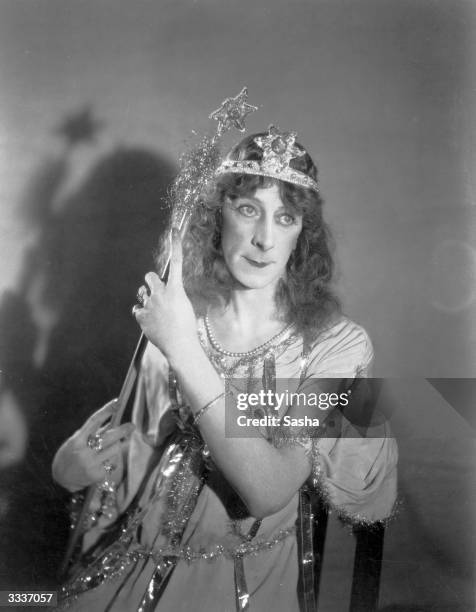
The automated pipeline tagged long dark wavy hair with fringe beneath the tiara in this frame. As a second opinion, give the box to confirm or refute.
[159,134,340,336]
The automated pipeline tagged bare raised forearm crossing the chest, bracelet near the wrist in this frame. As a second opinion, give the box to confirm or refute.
[170,340,310,516]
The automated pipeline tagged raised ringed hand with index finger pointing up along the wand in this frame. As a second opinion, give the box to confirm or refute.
[133,230,197,364]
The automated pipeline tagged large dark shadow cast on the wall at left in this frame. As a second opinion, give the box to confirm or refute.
[0,112,176,589]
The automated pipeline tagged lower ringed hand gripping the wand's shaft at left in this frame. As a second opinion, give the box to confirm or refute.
[53,400,135,492]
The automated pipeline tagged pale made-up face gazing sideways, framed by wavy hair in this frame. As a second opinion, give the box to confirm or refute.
[221,185,302,289]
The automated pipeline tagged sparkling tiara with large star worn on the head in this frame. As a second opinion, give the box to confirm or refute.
[215,125,319,192]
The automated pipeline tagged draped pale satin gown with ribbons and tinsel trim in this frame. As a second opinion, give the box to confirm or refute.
[58,317,397,612]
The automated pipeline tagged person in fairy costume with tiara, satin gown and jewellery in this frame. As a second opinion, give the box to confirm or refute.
[53,111,397,612]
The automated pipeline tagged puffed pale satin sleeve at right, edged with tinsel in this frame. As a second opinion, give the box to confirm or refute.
[294,320,398,523]
